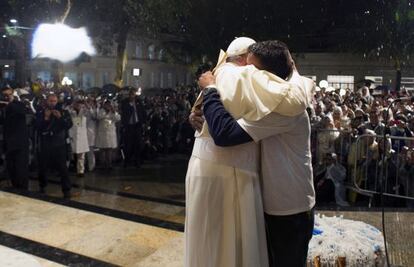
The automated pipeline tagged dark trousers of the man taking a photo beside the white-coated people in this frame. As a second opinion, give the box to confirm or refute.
[39,145,71,193]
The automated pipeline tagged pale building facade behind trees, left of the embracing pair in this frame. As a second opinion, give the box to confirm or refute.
[0,40,193,89]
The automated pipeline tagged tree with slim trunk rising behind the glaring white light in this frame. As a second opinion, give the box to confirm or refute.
[8,0,186,86]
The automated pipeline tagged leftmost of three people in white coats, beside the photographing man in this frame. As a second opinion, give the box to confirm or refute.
[69,100,89,177]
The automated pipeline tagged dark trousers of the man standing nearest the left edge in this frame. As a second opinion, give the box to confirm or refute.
[6,148,29,190]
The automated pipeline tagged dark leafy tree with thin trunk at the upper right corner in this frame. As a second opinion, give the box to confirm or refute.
[336,0,414,91]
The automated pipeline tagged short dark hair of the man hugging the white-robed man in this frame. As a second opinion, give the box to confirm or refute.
[249,40,293,79]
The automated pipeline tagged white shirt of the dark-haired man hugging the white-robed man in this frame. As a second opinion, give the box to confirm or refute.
[237,112,315,215]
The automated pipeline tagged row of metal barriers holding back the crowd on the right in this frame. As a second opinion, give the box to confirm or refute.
[311,130,414,208]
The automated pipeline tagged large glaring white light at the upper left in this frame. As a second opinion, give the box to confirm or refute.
[32,23,96,62]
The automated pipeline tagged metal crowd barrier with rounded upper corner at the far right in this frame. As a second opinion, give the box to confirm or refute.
[350,135,414,200]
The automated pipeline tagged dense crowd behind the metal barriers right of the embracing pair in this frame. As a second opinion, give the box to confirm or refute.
[308,86,414,207]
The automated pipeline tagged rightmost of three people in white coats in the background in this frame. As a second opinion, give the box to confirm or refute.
[96,100,121,169]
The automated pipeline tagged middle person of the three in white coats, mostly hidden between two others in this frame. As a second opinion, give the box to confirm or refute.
[86,98,98,172]
